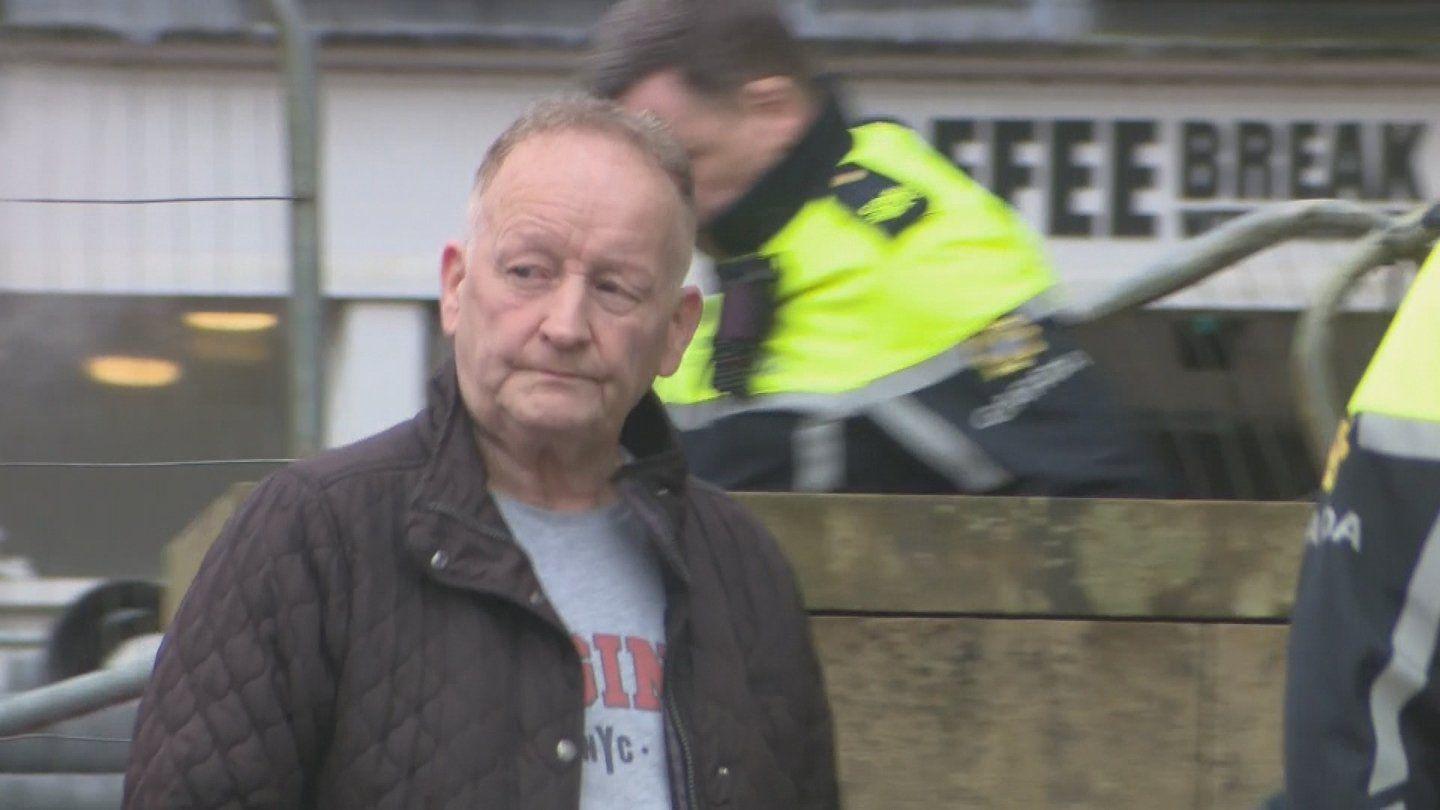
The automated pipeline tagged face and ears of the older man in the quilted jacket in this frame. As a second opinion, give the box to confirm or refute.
[441,131,700,440]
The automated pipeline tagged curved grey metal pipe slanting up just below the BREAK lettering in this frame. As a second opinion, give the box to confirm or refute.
[1063,200,1391,323]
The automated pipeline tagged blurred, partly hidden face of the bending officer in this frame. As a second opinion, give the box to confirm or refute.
[616,71,804,223]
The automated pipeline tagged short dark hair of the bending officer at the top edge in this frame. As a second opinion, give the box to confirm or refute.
[585,0,812,98]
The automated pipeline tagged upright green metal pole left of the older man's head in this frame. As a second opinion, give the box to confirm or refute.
[269,0,324,458]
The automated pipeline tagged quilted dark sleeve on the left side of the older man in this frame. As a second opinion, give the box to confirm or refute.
[124,471,348,809]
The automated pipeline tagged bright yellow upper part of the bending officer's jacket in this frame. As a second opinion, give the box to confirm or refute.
[655,112,1054,415]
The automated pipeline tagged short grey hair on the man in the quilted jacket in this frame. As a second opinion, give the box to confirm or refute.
[474,95,696,219]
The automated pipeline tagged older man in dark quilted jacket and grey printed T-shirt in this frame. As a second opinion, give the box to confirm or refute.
[125,99,838,810]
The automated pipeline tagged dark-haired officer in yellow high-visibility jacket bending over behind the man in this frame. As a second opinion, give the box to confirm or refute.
[589,0,1158,496]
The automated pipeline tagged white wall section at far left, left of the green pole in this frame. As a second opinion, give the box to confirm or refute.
[0,63,287,294]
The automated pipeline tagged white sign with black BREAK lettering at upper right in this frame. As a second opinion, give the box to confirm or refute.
[854,82,1440,308]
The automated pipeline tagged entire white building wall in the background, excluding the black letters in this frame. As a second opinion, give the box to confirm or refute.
[0,56,1440,308]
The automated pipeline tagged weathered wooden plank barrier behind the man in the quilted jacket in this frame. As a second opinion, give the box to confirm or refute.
[157,486,1308,810]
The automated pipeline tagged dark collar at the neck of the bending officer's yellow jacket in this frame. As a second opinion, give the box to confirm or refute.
[706,89,852,258]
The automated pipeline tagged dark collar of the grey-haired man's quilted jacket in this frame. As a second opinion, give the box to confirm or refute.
[405,359,688,601]
